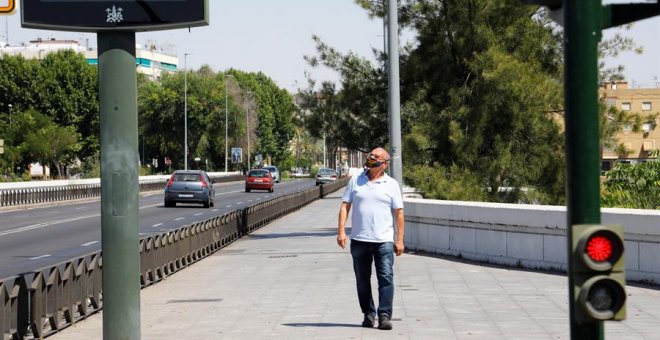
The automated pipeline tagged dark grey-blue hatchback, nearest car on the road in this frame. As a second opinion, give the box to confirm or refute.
[165,170,215,208]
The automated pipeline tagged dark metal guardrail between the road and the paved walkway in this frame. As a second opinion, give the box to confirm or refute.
[0,179,348,340]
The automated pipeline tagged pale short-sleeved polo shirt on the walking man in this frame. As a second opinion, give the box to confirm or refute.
[341,171,403,242]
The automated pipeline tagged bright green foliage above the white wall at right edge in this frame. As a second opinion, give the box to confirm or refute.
[601,161,660,209]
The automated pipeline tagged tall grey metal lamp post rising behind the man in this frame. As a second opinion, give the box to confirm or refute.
[387,0,403,186]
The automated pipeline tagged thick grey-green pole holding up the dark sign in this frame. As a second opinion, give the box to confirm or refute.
[98,32,140,340]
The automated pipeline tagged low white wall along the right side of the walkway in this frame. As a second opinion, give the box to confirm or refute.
[404,199,660,284]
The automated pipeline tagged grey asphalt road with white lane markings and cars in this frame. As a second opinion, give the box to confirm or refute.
[0,179,314,279]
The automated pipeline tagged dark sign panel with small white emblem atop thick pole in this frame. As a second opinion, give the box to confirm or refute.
[22,0,209,32]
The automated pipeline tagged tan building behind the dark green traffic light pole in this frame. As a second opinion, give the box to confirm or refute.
[601,81,660,170]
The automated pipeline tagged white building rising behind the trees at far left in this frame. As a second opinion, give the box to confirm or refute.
[0,39,178,80]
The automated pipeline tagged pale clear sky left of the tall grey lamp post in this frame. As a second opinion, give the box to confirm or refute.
[0,0,392,92]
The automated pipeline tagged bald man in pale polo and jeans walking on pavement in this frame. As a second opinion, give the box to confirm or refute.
[337,148,404,330]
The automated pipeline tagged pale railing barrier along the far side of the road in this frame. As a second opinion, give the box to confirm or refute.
[0,174,245,207]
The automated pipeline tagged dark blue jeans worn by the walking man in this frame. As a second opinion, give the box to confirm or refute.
[351,240,394,318]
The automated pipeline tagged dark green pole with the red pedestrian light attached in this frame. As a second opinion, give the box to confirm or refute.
[563,0,604,340]
